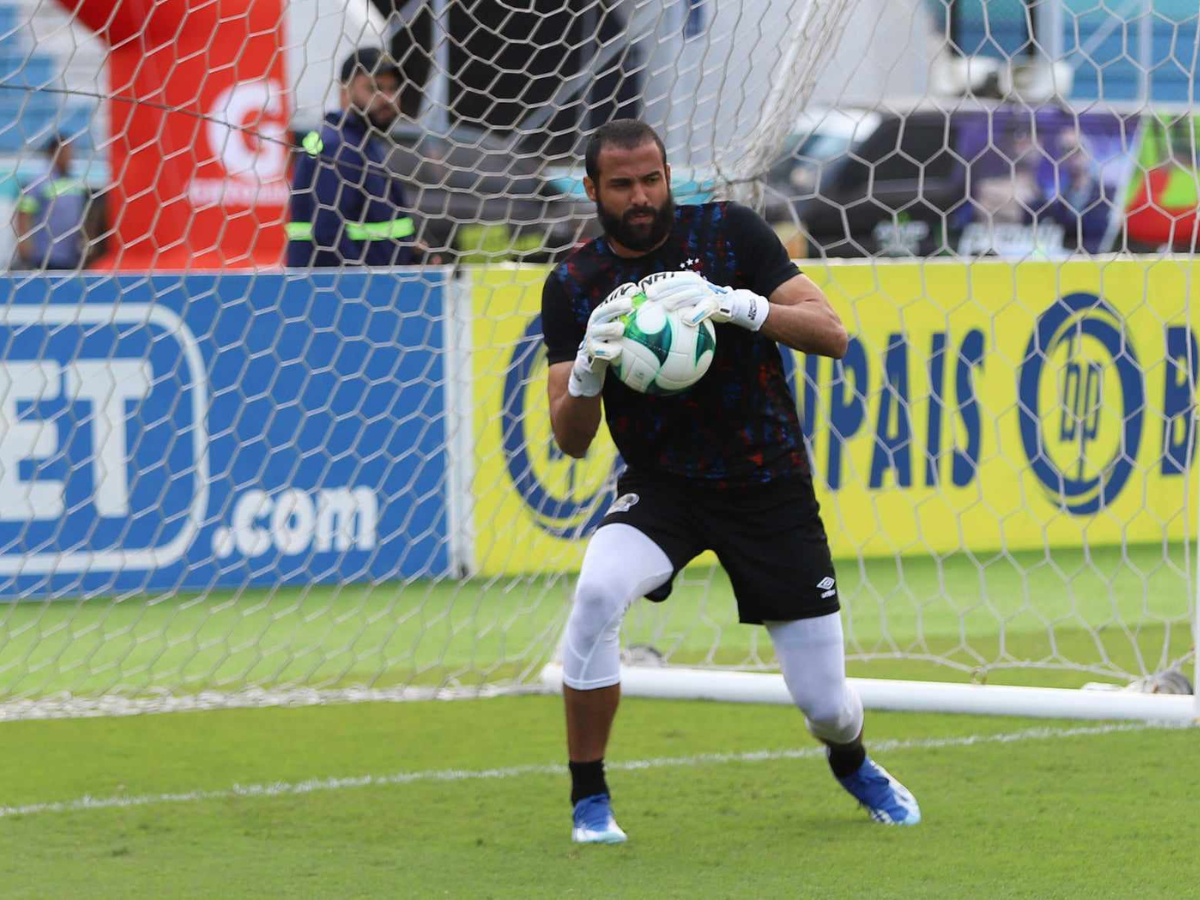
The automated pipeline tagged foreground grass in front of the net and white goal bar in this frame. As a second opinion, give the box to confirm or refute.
[0,696,1200,900]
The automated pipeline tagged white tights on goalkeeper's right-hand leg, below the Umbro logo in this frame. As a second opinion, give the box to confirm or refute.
[767,612,863,744]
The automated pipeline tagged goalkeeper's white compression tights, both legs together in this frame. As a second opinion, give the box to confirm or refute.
[563,523,863,744]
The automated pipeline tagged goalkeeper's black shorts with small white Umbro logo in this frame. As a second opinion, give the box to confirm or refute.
[600,470,840,624]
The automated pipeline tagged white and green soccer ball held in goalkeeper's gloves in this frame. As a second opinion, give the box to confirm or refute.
[612,293,716,395]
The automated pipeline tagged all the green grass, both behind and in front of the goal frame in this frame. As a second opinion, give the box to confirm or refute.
[0,546,1200,900]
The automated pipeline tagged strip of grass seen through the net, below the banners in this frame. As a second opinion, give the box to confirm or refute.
[0,545,1192,700]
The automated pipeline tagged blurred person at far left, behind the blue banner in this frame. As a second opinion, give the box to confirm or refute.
[17,136,89,269]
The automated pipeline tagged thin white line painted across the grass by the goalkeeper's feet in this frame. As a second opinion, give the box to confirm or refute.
[0,722,1192,818]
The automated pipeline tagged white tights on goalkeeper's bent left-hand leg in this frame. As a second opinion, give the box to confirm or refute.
[563,523,671,690]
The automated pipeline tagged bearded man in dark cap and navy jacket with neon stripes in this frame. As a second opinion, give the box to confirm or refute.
[287,47,415,266]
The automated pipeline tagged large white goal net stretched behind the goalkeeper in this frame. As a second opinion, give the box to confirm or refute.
[0,0,1200,718]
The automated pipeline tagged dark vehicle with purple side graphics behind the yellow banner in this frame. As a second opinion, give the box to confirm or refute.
[768,103,1138,258]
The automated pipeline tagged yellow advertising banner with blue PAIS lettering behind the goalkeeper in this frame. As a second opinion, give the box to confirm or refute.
[473,258,1200,574]
